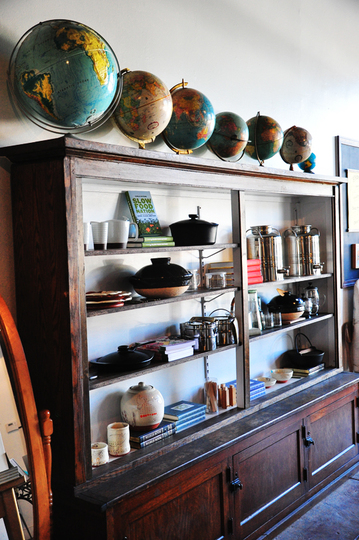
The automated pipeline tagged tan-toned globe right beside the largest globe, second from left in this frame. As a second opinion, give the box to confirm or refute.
[113,71,172,146]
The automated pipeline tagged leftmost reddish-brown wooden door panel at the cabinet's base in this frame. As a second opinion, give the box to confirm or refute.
[107,456,231,540]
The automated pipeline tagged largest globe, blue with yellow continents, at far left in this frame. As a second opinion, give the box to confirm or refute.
[9,20,122,133]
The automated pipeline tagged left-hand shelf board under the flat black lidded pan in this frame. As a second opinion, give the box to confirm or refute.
[90,344,237,390]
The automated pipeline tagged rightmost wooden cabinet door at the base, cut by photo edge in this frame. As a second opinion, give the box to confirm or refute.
[304,391,358,488]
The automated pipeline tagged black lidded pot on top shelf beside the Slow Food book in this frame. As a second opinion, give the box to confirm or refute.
[170,214,218,246]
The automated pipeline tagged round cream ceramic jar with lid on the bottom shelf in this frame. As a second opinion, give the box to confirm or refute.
[121,382,164,431]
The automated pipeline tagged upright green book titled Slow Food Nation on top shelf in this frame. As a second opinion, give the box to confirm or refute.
[126,191,163,236]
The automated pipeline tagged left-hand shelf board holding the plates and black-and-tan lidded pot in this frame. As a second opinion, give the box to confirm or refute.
[87,287,237,317]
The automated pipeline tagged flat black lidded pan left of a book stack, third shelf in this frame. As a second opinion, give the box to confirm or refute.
[91,345,154,371]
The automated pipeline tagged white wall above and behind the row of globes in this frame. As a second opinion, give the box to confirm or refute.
[0,0,359,532]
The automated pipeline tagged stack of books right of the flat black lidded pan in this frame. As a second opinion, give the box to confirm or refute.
[136,336,196,362]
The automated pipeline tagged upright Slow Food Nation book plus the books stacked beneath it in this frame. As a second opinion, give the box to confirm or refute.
[126,191,175,248]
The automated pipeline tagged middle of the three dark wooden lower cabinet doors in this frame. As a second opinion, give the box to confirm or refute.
[233,419,305,538]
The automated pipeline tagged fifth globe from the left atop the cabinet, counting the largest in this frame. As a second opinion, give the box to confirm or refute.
[245,113,283,163]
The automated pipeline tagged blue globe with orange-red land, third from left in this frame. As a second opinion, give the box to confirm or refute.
[162,82,215,153]
